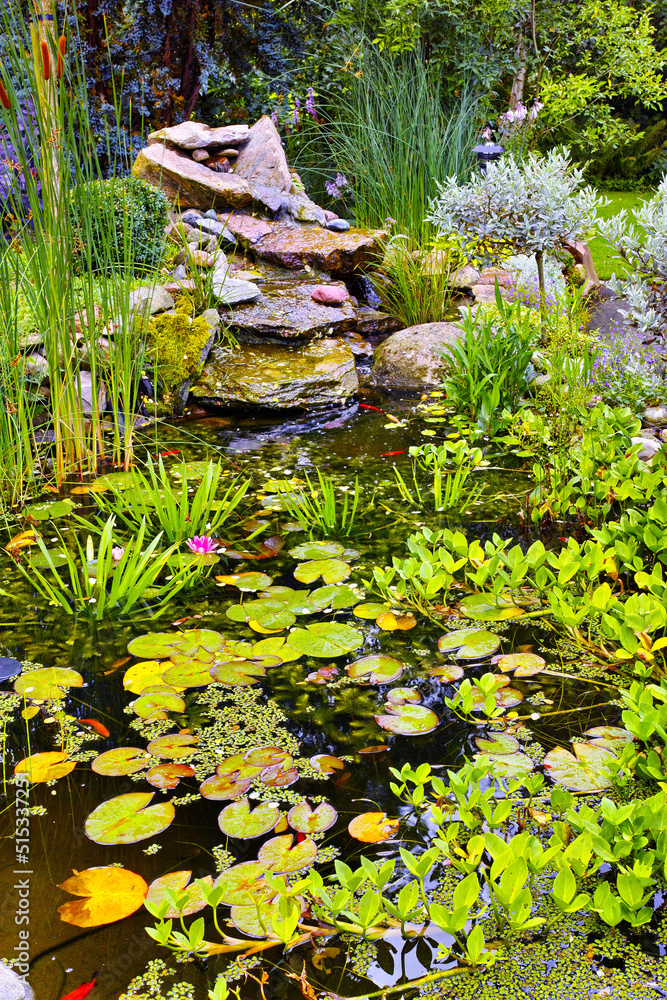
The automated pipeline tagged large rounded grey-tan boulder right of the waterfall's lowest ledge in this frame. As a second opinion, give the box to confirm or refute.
[370,323,463,390]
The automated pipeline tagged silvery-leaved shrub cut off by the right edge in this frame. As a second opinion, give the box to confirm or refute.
[598,180,667,343]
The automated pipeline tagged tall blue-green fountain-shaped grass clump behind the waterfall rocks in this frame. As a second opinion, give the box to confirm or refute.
[329,42,480,245]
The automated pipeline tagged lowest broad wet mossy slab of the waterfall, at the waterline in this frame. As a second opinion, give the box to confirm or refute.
[191,340,359,409]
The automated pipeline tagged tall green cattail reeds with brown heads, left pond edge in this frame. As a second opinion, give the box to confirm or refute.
[0,4,161,484]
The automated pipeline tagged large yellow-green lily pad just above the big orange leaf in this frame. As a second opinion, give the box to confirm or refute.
[84,792,176,844]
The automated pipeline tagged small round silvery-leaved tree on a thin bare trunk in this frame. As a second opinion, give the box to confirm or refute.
[427,149,600,302]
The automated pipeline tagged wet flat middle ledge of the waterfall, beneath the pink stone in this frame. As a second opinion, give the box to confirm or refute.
[224,278,356,341]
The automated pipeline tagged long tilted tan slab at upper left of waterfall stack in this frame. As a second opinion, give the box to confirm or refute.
[132,144,253,210]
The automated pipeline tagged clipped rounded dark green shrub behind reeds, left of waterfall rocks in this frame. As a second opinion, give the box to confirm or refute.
[72,177,169,272]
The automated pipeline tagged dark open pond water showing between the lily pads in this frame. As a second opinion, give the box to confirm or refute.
[0,396,667,1000]
